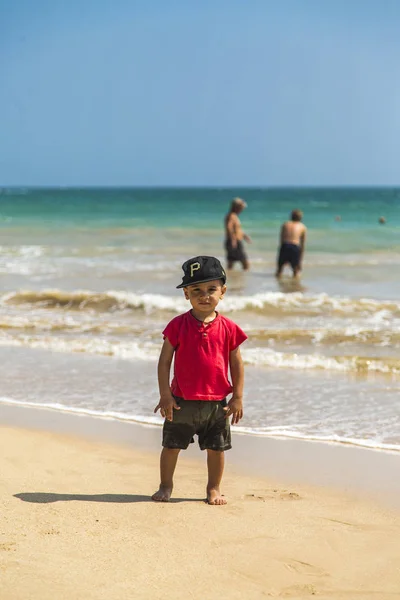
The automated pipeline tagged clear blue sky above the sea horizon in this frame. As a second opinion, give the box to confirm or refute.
[0,0,400,186]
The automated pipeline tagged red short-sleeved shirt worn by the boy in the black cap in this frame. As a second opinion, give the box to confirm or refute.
[163,311,247,400]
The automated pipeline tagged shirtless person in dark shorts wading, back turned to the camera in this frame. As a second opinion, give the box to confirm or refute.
[275,209,307,277]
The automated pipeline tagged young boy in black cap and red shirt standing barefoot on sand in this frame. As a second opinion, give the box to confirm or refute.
[152,256,247,504]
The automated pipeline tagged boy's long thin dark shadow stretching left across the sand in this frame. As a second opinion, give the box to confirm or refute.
[14,492,205,504]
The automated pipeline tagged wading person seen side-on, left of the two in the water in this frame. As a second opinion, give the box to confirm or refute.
[225,198,251,271]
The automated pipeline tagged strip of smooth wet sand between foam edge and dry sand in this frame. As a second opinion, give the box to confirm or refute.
[0,404,400,510]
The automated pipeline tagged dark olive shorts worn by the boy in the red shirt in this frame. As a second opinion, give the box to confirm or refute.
[162,398,232,451]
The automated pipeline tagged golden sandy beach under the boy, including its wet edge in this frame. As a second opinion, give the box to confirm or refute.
[0,406,400,600]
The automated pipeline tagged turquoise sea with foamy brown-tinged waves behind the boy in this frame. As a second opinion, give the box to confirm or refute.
[0,188,400,452]
